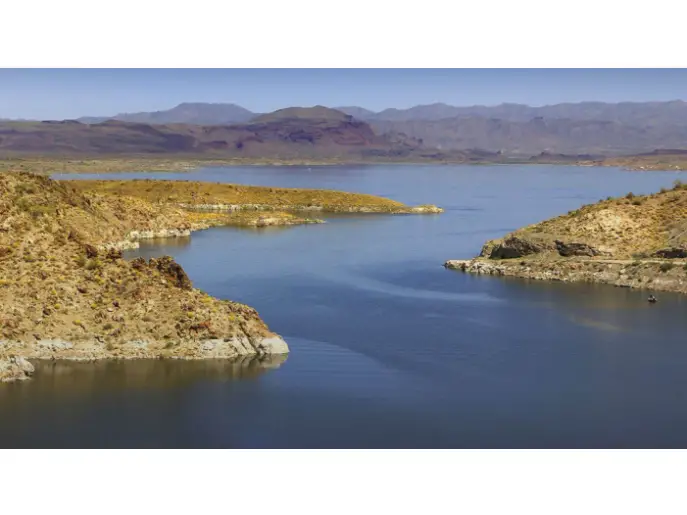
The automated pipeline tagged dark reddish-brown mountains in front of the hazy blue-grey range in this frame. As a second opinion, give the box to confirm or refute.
[0,106,478,161]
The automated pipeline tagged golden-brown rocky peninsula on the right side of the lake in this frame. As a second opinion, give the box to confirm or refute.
[444,181,687,293]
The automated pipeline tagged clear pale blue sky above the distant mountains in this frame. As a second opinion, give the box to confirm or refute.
[0,69,687,119]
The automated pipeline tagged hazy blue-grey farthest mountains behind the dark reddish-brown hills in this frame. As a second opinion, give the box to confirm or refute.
[61,100,687,156]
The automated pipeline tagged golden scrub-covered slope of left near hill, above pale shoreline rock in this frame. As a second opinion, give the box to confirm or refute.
[0,173,269,352]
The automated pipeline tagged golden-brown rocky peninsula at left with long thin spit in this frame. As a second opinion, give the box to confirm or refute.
[0,172,441,381]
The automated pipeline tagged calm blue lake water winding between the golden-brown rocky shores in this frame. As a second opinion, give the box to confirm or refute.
[5,166,687,448]
